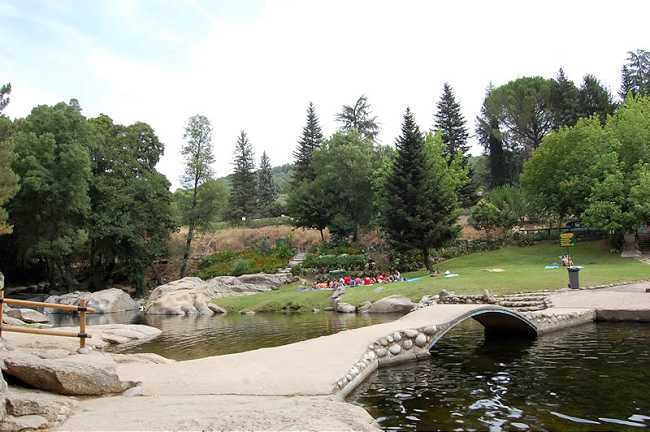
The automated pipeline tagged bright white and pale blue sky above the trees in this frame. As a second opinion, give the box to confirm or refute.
[0,0,650,187]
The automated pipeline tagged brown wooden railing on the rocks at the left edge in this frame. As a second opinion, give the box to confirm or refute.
[0,290,96,348]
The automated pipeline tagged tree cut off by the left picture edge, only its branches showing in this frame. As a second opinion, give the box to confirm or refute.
[0,84,18,235]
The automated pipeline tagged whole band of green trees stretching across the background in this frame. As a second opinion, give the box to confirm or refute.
[0,50,650,293]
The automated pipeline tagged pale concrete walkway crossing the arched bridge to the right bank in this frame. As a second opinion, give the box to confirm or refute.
[61,283,650,431]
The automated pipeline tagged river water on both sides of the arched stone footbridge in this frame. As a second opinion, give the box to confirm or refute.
[56,312,650,431]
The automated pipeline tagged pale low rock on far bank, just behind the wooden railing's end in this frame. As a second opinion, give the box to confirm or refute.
[45,288,139,314]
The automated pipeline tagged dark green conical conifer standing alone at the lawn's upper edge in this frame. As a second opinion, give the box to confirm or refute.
[383,108,461,270]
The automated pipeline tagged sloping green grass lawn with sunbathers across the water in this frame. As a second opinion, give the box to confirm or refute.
[211,241,650,312]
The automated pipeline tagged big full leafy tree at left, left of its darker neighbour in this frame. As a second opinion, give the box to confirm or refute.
[9,103,93,288]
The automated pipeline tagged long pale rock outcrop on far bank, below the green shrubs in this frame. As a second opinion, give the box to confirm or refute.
[145,273,296,315]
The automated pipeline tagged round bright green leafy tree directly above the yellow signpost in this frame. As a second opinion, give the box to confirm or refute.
[521,118,618,219]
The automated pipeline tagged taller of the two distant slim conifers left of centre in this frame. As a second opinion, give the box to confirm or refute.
[228,131,257,223]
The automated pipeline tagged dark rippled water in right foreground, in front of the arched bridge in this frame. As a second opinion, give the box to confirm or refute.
[351,322,650,431]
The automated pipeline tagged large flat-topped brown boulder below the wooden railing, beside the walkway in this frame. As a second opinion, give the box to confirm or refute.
[4,353,137,396]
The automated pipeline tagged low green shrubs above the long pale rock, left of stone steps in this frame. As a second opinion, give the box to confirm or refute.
[197,245,294,279]
